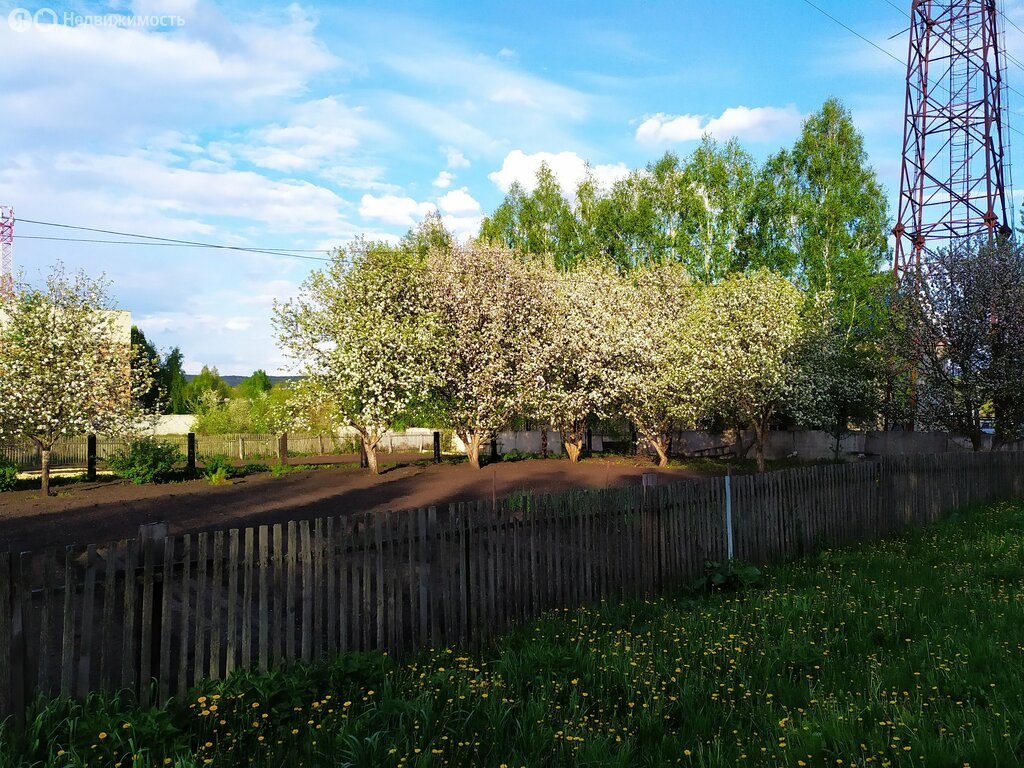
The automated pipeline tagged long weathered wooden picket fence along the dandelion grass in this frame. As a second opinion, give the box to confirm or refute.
[0,453,1024,718]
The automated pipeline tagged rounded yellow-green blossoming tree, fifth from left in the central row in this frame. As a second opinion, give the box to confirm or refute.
[683,270,817,472]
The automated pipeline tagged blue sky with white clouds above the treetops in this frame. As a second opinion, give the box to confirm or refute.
[0,0,1024,374]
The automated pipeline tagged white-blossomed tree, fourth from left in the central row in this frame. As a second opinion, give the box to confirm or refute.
[605,263,703,466]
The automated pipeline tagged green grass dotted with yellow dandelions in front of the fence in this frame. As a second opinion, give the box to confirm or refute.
[0,503,1024,768]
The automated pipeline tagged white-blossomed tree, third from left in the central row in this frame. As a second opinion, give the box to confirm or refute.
[530,262,623,462]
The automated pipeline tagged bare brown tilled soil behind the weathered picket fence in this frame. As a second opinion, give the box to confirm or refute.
[0,454,698,551]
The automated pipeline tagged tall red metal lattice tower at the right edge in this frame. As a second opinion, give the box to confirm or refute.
[893,0,1011,288]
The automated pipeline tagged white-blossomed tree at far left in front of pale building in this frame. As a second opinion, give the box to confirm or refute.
[0,266,153,496]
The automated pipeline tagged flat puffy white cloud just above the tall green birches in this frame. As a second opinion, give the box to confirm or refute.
[636,104,804,144]
